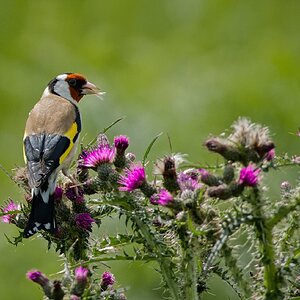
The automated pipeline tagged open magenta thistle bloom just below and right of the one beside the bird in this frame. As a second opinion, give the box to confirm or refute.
[119,164,146,192]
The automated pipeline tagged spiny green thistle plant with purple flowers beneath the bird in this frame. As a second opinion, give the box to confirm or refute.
[2,118,300,300]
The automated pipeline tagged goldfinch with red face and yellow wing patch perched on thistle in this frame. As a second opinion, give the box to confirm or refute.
[23,73,103,238]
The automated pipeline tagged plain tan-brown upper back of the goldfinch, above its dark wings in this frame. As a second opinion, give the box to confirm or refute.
[25,95,76,135]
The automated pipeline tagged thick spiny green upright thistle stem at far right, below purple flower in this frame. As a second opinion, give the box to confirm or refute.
[253,188,283,300]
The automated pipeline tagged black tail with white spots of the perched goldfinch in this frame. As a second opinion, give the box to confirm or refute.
[23,189,56,238]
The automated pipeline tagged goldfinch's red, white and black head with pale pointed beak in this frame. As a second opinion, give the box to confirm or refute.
[44,73,103,102]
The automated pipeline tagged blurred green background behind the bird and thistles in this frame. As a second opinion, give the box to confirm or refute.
[0,0,300,300]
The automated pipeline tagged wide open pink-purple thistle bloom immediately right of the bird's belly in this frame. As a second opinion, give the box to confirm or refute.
[82,145,116,168]
